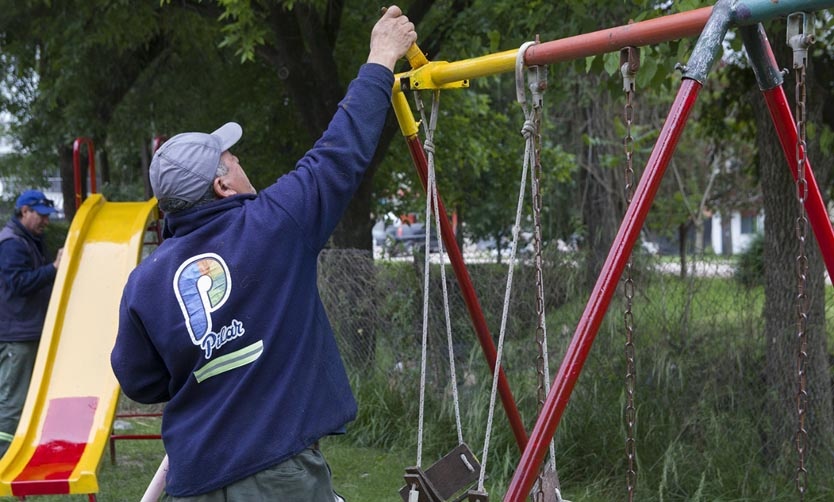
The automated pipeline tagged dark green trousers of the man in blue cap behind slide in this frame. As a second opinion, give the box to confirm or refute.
[0,340,38,457]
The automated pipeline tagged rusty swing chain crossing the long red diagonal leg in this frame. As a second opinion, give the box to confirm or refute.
[620,47,640,502]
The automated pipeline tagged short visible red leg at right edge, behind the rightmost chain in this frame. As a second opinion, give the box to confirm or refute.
[762,86,834,278]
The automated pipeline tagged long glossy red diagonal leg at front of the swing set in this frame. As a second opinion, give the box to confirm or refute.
[504,78,701,502]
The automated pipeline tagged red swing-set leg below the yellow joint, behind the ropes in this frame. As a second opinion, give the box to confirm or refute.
[406,136,527,451]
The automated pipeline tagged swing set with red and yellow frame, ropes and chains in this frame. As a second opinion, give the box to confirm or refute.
[392,0,834,502]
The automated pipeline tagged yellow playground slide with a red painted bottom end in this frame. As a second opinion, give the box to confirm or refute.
[0,194,156,496]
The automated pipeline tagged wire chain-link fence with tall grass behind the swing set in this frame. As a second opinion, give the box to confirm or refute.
[319,245,834,499]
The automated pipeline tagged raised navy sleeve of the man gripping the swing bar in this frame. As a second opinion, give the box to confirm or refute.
[261,63,394,250]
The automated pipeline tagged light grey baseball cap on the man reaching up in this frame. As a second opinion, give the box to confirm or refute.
[150,122,243,203]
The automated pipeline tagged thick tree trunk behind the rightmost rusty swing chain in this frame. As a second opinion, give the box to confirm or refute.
[753,35,834,479]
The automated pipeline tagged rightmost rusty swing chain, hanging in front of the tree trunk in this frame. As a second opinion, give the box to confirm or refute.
[796,60,809,500]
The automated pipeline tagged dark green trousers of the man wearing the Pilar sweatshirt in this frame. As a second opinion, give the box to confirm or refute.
[161,448,341,502]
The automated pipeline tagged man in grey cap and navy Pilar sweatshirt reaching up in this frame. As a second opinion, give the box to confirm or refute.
[111,6,417,502]
